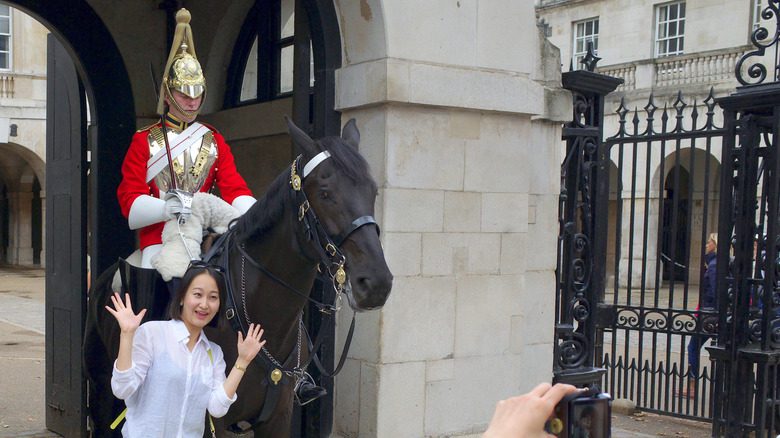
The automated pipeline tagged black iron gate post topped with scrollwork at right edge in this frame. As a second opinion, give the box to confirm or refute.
[709,15,780,437]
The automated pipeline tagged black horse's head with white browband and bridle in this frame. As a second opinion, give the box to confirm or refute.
[287,119,393,310]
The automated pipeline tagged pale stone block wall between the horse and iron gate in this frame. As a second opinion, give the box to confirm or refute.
[334,0,570,437]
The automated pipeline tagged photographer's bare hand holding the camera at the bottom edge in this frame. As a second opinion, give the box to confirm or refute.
[482,383,577,438]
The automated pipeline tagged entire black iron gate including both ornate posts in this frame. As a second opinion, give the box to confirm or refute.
[554,8,780,437]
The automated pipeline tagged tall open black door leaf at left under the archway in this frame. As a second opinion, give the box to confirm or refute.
[45,34,87,437]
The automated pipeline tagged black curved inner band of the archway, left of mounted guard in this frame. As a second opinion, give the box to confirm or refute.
[8,0,135,272]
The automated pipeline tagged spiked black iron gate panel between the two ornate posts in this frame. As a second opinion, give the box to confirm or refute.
[596,91,725,418]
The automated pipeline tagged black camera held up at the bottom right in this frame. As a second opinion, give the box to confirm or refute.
[544,388,612,438]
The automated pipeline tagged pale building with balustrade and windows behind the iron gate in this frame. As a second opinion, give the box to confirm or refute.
[536,0,756,288]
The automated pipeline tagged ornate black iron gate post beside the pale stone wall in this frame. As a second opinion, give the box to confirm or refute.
[553,48,623,386]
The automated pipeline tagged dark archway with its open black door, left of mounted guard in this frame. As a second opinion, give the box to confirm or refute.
[6,0,135,436]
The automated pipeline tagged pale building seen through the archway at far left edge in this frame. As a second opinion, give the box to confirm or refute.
[0,3,49,266]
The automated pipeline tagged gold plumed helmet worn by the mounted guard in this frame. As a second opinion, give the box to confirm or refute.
[157,8,206,116]
